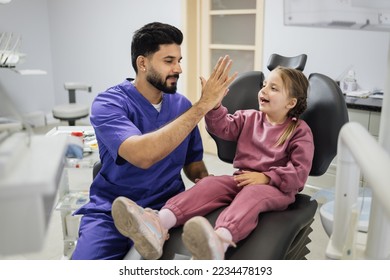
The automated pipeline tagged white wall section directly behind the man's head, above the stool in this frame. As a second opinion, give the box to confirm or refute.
[48,0,181,116]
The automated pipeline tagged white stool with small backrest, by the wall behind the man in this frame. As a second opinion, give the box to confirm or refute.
[52,83,92,126]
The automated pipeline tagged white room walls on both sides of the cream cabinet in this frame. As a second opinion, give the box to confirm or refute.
[0,0,389,122]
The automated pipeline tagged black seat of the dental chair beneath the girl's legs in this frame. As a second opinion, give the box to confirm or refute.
[155,192,317,260]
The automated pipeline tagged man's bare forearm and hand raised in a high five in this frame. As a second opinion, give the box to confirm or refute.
[119,56,237,168]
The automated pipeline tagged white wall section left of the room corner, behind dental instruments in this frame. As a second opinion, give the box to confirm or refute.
[0,0,54,116]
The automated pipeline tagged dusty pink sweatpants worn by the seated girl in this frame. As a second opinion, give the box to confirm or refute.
[163,175,295,242]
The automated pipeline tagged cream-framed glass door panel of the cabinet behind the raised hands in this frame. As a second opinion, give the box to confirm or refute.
[203,0,264,73]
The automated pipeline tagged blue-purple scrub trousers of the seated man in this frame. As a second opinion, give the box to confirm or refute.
[72,213,133,260]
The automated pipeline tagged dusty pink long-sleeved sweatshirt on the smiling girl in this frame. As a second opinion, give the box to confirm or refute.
[205,106,314,193]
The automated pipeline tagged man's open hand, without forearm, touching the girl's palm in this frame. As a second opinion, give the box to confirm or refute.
[198,55,237,111]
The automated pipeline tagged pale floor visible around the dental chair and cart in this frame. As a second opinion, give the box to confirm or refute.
[0,123,329,260]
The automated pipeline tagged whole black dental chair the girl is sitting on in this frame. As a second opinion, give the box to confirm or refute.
[94,53,348,260]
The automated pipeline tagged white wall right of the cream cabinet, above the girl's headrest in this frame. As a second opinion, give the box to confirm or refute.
[263,0,389,89]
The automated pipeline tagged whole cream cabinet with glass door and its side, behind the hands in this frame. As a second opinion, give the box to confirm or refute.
[189,0,264,154]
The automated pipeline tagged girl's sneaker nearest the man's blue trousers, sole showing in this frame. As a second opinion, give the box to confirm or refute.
[111,197,169,260]
